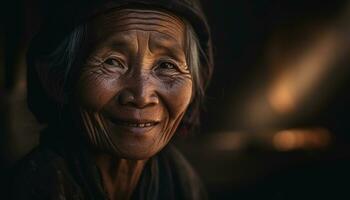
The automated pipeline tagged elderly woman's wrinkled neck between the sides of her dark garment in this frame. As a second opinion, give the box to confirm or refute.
[95,154,147,199]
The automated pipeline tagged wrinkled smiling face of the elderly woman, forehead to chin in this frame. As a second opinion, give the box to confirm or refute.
[76,9,192,159]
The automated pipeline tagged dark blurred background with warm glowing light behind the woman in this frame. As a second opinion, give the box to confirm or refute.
[0,0,350,199]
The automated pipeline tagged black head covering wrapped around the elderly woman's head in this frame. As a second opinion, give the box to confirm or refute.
[27,0,213,123]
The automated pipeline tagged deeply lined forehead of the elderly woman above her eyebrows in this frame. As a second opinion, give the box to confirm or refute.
[89,9,185,46]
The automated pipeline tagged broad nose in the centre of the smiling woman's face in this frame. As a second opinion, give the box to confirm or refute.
[117,75,159,108]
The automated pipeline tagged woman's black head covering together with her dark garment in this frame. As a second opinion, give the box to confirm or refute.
[17,0,213,200]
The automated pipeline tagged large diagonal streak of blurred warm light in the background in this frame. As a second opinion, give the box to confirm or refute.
[267,29,343,114]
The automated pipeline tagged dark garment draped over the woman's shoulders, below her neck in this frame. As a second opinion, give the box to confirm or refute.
[12,141,206,200]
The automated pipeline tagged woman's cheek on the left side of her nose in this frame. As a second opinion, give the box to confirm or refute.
[76,73,119,111]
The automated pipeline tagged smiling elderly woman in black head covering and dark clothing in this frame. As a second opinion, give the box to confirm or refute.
[12,0,212,199]
